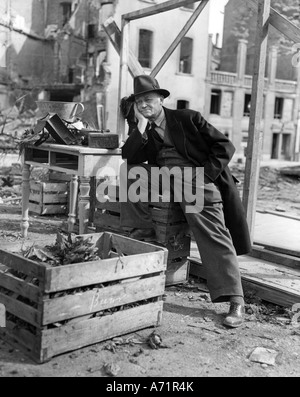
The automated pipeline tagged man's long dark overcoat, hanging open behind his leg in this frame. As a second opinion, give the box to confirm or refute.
[122,107,251,255]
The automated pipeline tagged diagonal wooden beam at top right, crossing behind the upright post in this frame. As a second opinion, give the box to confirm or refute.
[247,0,300,43]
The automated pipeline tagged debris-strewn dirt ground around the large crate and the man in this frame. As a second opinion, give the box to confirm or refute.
[0,160,300,382]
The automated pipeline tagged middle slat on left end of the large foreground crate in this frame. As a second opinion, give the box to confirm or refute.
[0,292,42,327]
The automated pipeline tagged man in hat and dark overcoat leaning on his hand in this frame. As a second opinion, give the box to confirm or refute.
[121,75,251,327]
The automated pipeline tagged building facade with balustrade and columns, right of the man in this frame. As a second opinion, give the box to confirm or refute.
[205,0,300,161]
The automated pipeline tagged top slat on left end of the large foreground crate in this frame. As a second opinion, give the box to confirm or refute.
[0,249,48,280]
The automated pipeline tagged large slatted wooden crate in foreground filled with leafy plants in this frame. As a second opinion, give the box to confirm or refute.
[0,233,168,363]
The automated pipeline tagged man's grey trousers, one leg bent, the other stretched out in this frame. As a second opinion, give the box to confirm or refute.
[120,163,243,302]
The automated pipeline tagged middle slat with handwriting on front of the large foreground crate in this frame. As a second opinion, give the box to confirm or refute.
[43,275,165,325]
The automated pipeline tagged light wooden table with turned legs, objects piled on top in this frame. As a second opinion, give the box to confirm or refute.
[21,143,122,237]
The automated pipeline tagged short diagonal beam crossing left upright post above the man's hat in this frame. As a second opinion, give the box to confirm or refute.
[102,17,145,77]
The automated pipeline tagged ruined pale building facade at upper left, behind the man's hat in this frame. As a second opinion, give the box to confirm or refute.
[0,0,209,132]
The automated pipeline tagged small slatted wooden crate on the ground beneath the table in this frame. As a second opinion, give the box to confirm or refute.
[29,181,69,215]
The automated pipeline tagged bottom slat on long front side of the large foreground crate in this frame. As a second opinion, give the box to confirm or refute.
[42,301,163,361]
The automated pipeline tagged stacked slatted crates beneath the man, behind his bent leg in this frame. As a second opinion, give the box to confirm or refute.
[94,186,191,286]
